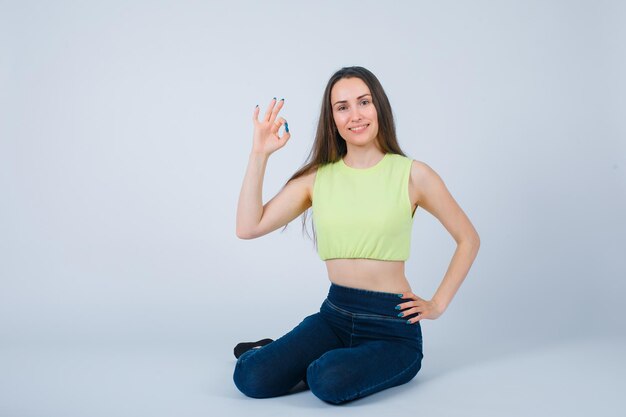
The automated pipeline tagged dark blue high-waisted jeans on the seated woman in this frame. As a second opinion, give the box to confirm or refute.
[233,284,424,404]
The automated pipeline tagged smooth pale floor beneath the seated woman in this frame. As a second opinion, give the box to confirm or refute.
[0,339,626,417]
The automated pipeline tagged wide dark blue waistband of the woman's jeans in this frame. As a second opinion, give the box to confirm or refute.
[328,283,408,317]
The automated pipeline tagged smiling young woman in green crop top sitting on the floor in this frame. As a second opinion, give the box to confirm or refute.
[233,67,480,404]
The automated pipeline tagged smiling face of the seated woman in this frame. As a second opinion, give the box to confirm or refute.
[330,77,378,146]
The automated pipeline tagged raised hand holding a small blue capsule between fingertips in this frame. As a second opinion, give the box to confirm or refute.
[252,98,291,156]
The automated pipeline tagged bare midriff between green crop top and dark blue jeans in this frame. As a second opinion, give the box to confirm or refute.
[325,258,411,293]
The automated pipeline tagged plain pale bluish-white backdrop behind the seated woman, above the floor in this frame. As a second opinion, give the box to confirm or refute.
[0,0,626,415]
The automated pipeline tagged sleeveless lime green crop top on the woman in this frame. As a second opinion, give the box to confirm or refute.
[312,153,413,261]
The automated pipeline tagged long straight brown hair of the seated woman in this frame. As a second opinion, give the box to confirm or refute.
[283,66,406,248]
